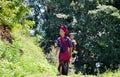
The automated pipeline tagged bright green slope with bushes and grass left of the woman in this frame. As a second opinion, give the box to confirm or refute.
[0,0,57,77]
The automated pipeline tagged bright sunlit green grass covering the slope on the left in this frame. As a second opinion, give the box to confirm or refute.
[0,31,57,77]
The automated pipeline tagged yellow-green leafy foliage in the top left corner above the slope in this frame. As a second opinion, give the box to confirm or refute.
[0,0,34,28]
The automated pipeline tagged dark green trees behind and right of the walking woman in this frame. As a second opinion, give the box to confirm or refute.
[41,0,120,74]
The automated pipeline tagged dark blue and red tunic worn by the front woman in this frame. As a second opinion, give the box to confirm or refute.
[57,37,72,64]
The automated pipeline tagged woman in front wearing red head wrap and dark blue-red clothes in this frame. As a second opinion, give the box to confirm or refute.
[56,25,72,75]
